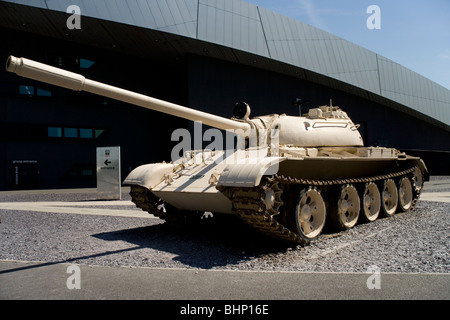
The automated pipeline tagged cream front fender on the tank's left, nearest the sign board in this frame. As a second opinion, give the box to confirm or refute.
[123,163,175,190]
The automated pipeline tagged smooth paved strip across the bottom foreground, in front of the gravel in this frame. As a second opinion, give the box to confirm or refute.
[0,261,450,300]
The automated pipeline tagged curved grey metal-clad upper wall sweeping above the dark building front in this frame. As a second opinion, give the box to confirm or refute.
[4,0,450,128]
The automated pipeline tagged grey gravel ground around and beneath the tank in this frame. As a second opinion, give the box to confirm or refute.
[0,192,450,273]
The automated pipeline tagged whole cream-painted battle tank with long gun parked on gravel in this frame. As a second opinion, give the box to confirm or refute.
[6,56,429,244]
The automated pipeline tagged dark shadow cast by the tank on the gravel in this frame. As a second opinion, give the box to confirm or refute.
[93,218,292,269]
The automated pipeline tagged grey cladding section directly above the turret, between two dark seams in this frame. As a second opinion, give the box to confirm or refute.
[259,8,380,93]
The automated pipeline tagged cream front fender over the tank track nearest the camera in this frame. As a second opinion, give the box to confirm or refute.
[217,157,286,187]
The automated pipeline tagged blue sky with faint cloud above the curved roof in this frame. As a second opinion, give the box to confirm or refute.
[246,0,450,89]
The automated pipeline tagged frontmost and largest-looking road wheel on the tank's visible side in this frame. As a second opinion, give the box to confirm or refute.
[287,187,326,241]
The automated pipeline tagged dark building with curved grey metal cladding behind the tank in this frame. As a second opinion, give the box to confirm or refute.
[0,0,450,189]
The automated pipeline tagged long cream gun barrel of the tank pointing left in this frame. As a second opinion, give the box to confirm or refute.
[6,56,250,134]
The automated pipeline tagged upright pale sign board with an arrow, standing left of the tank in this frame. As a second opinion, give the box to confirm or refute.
[97,147,122,200]
